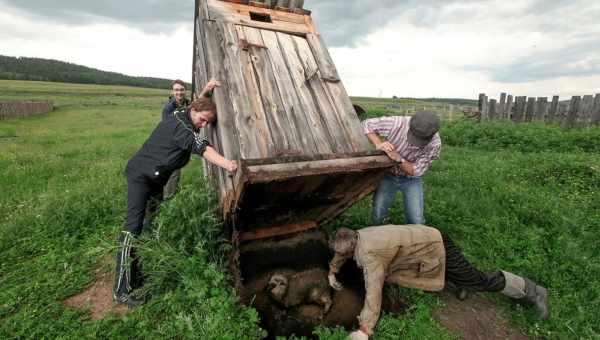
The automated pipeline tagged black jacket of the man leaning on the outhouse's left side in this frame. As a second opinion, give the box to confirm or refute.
[125,109,210,184]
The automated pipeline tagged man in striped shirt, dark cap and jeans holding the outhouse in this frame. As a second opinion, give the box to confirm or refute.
[363,111,442,225]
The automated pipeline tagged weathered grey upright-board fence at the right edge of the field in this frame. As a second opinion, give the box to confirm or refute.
[478,93,600,128]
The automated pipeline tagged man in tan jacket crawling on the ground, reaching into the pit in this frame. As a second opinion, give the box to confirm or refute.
[329,225,548,339]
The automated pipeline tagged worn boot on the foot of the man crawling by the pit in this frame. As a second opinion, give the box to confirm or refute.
[502,271,549,320]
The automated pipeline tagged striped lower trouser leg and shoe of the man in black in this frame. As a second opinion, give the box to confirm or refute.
[113,231,144,308]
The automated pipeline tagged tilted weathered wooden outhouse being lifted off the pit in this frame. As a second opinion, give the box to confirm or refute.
[193,0,393,242]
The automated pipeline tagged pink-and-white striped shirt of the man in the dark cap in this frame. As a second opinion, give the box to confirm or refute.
[362,116,442,177]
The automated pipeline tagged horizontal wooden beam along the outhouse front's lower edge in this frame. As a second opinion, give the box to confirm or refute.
[246,156,395,183]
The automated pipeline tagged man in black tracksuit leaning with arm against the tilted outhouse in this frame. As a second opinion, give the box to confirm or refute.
[113,91,237,307]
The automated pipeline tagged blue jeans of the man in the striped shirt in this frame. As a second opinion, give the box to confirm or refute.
[373,172,425,225]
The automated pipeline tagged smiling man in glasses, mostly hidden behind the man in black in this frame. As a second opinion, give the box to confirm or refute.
[162,79,220,201]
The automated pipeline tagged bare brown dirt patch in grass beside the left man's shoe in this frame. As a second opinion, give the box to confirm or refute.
[63,258,129,321]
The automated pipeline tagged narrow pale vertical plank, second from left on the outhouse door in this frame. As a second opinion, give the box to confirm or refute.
[261,30,317,154]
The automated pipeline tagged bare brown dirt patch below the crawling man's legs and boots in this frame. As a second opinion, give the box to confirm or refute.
[434,293,529,340]
